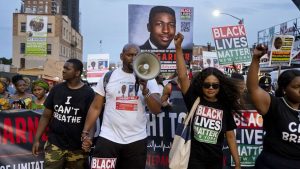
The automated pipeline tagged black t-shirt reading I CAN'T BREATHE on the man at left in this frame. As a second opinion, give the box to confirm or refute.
[45,82,95,150]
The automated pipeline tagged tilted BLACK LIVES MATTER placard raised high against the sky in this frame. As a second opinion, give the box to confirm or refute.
[212,24,252,65]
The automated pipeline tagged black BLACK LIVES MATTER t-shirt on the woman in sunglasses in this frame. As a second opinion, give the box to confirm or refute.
[184,88,236,162]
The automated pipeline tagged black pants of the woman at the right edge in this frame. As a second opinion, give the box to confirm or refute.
[255,151,300,169]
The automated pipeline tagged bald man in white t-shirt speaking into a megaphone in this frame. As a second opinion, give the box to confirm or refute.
[82,44,161,169]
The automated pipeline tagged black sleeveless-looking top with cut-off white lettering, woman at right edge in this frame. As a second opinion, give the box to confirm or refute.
[263,95,300,160]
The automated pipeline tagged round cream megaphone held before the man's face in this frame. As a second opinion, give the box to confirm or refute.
[133,52,160,80]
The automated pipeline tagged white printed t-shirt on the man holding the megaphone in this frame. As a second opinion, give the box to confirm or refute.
[95,68,159,144]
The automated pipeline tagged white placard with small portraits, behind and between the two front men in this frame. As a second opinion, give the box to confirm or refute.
[87,54,109,83]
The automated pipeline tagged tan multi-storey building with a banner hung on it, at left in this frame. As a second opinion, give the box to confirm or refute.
[12,12,83,69]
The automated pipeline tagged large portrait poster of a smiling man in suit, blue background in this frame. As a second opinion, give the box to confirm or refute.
[128,5,194,72]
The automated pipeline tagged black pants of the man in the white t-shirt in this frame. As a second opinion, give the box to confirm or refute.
[91,137,147,169]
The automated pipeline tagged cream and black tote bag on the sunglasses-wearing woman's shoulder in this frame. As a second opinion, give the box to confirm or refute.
[169,97,200,169]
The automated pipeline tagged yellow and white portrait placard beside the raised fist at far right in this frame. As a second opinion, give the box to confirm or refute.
[270,35,295,66]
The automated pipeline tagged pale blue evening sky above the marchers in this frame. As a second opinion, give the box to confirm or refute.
[0,0,300,63]
